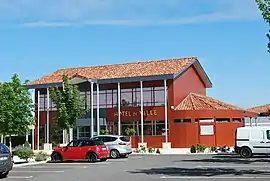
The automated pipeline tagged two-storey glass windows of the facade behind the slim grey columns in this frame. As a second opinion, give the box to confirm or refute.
[39,85,169,144]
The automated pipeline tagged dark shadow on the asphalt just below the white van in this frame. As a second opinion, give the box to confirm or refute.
[173,155,270,164]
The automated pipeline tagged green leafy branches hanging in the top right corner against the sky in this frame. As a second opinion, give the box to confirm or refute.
[256,0,270,53]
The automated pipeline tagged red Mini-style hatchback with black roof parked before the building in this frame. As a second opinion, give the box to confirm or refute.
[51,139,109,162]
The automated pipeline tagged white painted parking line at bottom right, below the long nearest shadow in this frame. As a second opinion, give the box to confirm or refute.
[160,176,270,180]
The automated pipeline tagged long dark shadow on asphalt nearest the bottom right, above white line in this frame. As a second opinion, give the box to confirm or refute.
[129,167,270,177]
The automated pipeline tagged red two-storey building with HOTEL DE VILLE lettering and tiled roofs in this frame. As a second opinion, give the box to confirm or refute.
[25,57,254,148]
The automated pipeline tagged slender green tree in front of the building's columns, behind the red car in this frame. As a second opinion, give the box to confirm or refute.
[50,75,87,142]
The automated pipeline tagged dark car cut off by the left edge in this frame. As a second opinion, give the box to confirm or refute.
[0,143,13,178]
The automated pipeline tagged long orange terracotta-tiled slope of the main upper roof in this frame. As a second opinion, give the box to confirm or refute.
[29,57,197,85]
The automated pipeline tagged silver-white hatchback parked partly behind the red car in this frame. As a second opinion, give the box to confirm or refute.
[93,135,132,159]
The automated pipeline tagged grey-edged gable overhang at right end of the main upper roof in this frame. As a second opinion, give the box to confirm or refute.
[174,59,213,88]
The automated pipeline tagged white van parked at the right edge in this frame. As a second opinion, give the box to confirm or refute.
[234,126,270,158]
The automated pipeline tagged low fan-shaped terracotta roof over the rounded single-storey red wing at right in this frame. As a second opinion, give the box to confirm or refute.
[175,93,244,110]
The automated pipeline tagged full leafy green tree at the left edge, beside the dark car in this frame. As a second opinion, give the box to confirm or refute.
[0,74,34,148]
